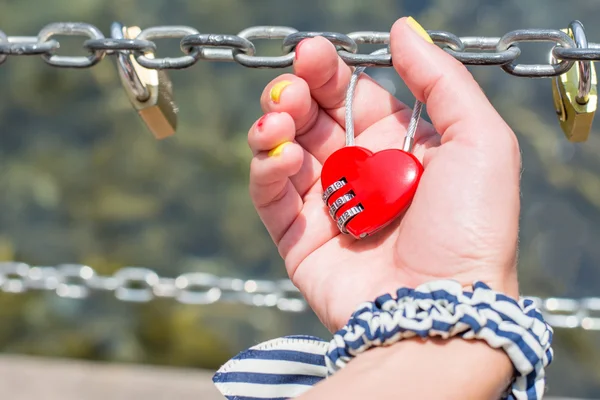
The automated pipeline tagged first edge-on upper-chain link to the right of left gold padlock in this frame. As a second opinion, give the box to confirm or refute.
[181,33,256,61]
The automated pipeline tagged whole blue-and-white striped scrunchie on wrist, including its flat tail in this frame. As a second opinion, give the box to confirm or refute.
[213,280,553,400]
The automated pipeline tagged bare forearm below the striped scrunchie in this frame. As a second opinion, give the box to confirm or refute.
[299,338,513,400]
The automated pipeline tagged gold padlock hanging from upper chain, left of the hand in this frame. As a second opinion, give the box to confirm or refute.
[112,23,179,139]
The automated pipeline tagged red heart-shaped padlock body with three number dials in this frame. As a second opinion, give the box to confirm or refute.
[321,146,423,239]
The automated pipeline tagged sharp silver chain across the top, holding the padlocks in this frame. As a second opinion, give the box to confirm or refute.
[0,22,600,77]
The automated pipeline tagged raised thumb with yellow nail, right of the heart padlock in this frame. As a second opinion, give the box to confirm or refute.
[390,18,514,152]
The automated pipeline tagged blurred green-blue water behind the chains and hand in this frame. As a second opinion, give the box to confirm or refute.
[0,0,600,398]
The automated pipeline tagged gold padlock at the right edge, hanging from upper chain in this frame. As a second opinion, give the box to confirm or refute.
[552,21,598,142]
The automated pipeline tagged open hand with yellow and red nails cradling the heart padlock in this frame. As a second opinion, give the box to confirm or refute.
[248,18,521,331]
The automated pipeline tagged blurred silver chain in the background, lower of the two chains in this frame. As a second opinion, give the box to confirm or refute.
[0,262,600,330]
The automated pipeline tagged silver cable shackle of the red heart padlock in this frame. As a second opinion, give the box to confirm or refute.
[345,47,423,152]
